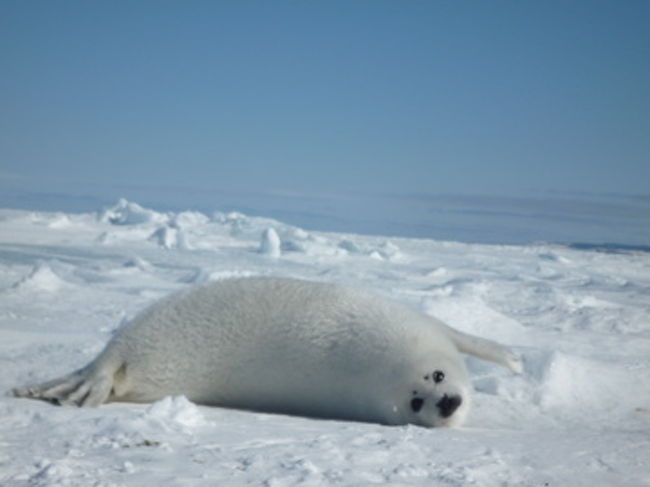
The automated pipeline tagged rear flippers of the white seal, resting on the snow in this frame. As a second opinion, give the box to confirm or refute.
[11,367,113,407]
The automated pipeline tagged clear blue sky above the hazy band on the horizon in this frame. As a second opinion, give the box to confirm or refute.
[0,0,650,244]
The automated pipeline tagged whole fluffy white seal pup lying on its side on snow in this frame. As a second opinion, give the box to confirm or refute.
[13,278,521,426]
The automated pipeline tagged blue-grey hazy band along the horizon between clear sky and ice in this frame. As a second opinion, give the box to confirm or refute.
[0,185,650,252]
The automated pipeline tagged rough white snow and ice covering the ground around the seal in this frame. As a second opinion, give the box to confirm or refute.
[0,200,650,486]
